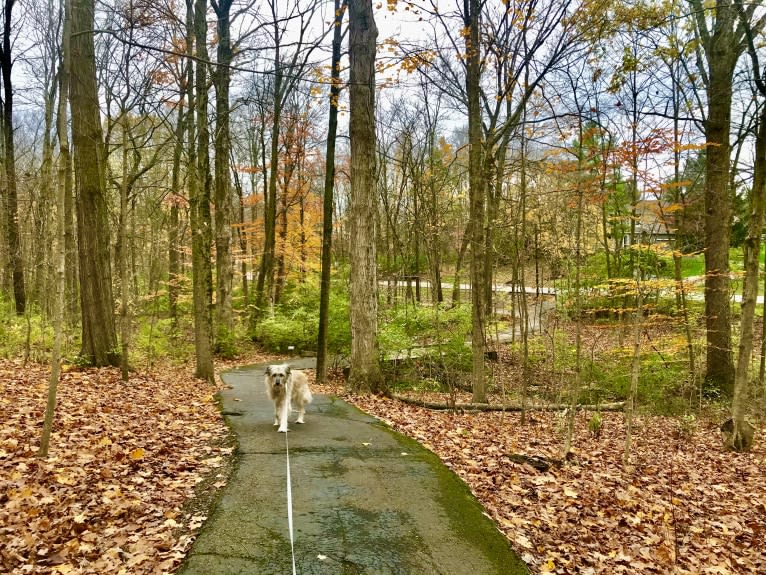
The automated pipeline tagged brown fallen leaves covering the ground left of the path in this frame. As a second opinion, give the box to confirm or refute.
[0,360,232,574]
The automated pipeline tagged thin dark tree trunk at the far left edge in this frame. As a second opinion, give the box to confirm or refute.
[0,0,27,315]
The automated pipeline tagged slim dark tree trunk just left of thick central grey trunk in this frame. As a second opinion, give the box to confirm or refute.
[316,0,346,383]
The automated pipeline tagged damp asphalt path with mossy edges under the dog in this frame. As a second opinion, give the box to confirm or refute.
[179,360,527,575]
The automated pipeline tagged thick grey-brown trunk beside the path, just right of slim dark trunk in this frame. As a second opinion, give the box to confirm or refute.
[348,0,384,393]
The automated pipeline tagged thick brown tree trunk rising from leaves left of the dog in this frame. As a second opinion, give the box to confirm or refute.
[70,0,119,366]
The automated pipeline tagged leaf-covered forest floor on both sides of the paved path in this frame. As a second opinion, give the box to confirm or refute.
[0,356,766,575]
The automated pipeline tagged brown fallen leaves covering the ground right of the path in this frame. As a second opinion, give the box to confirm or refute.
[351,397,766,575]
